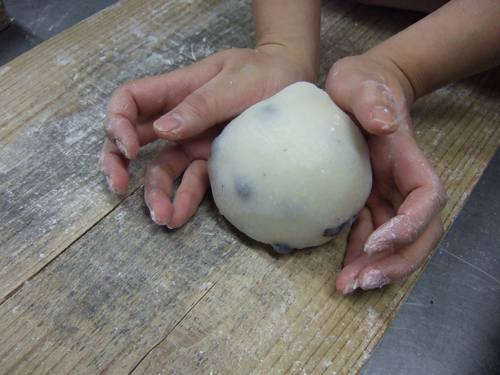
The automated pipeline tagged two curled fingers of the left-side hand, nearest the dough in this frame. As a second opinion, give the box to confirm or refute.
[144,144,209,229]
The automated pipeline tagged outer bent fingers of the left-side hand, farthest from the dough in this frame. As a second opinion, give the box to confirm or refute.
[100,57,224,195]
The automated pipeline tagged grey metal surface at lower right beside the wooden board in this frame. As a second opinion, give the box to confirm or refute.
[362,151,500,375]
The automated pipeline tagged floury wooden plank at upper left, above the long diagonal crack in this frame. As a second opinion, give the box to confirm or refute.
[0,1,258,301]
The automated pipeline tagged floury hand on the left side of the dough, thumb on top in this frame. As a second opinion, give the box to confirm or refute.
[99,44,316,228]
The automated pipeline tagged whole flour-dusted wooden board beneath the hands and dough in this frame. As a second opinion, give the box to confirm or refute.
[0,0,500,374]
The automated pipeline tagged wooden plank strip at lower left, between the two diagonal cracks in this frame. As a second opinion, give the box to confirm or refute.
[0,190,241,374]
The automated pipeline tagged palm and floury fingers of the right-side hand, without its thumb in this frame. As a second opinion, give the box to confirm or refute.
[337,128,444,293]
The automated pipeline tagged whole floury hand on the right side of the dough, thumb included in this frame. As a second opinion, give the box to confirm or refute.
[327,56,446,294]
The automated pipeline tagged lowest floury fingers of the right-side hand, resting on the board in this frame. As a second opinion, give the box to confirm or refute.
[337,217,443,294]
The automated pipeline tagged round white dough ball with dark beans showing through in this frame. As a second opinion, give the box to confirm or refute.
[208,82,372,253]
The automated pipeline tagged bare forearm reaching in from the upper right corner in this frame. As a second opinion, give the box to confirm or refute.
[369,0,500,100]
